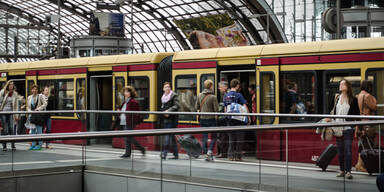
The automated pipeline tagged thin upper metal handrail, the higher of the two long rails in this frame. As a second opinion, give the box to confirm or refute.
[4,110,384,120]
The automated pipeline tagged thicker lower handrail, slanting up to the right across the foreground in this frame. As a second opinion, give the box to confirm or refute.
[0,120,384,143]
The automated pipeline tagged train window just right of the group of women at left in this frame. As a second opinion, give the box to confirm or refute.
[57,79,74,116]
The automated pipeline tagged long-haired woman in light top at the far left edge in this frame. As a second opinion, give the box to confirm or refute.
[0,80,19,151]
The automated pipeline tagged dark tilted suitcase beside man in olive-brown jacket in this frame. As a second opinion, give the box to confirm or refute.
[176,135,202,158]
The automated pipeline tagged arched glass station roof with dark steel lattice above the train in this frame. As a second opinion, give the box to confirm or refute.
[0,0,287,62]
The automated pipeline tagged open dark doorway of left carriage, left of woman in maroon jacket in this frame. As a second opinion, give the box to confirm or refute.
[89,75,113,144]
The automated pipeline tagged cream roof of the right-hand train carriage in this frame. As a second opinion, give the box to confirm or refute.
[173,37,384,62]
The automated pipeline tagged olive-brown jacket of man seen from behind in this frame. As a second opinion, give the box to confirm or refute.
[195,89,219,119]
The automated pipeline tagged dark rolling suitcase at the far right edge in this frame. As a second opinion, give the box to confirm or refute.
[360,137,384,175]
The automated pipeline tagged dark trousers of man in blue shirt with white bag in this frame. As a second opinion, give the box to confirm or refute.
[228,119,245,159]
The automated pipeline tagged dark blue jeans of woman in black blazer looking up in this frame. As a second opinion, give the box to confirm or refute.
[336,129,353,172]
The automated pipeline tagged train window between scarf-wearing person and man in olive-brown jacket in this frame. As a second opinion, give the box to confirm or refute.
[176,75,197,121]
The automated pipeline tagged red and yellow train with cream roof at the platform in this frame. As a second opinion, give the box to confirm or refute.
[0,37,384,162]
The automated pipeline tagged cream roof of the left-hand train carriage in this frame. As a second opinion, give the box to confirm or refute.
[0,53,173,71]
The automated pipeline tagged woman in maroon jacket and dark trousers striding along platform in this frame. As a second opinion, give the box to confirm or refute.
[119,86,145,158]
